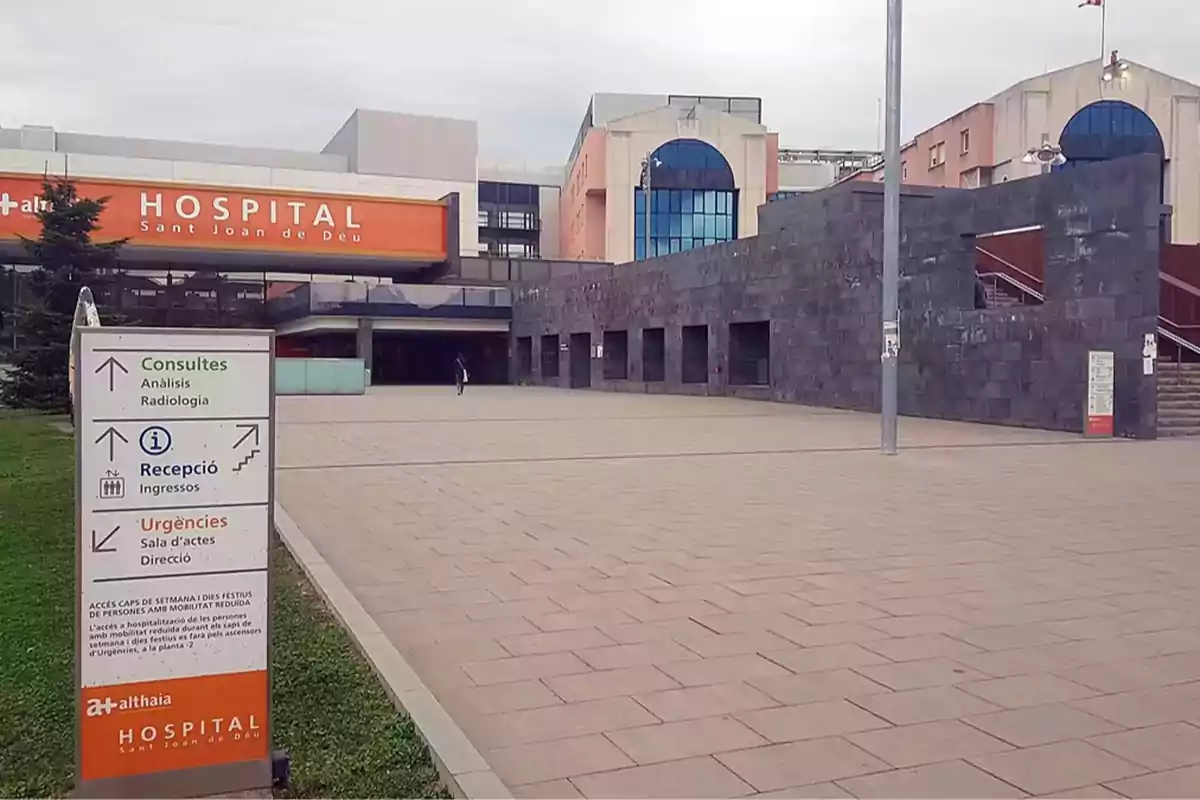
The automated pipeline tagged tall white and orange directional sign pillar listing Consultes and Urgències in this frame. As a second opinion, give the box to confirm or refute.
[76,327,275,798]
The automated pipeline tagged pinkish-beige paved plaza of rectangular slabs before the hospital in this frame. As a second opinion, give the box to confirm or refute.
[277,386,1200,798]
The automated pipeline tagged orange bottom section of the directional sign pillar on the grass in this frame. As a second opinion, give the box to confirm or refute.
[79,670,270,781]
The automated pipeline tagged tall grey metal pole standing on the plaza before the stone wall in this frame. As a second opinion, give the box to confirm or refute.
[880,0,904,456]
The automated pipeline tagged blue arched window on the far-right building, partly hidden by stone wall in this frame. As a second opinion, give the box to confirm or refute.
[1056,100,1166,169]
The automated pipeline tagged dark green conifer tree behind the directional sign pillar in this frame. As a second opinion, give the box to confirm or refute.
[0,178,127,411]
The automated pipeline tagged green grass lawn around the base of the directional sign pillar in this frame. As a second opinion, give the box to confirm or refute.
[0,413,449,798]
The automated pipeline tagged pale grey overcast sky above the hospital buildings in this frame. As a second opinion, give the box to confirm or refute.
[0,0,1200,167]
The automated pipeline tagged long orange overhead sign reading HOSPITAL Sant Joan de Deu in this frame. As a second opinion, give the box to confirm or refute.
[0,174,448,261]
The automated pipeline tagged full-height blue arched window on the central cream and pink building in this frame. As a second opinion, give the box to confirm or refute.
[634,139,738,260]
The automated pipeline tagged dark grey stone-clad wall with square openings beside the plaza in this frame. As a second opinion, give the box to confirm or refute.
[512,156,1163,438]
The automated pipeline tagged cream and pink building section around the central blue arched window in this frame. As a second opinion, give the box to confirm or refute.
[558,95,779,264]
